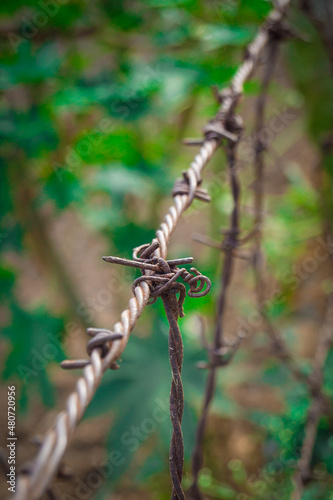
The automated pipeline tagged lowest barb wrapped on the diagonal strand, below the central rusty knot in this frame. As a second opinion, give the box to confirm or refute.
[60,328,123,370]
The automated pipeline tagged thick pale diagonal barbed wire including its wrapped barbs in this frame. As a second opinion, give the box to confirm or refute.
[14,0,290,500]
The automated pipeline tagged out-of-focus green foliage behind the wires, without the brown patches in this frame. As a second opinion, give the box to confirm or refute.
[0,0,333,500]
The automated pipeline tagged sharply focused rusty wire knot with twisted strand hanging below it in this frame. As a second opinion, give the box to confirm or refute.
[105,243,211,500]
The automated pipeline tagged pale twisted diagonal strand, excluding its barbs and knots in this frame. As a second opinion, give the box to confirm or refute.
[14,0,289,500]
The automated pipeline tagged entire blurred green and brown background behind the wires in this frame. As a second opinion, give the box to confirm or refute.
[0,0,333,500]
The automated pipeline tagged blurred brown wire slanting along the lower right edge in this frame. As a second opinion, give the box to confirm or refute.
[293,294,333,500]
